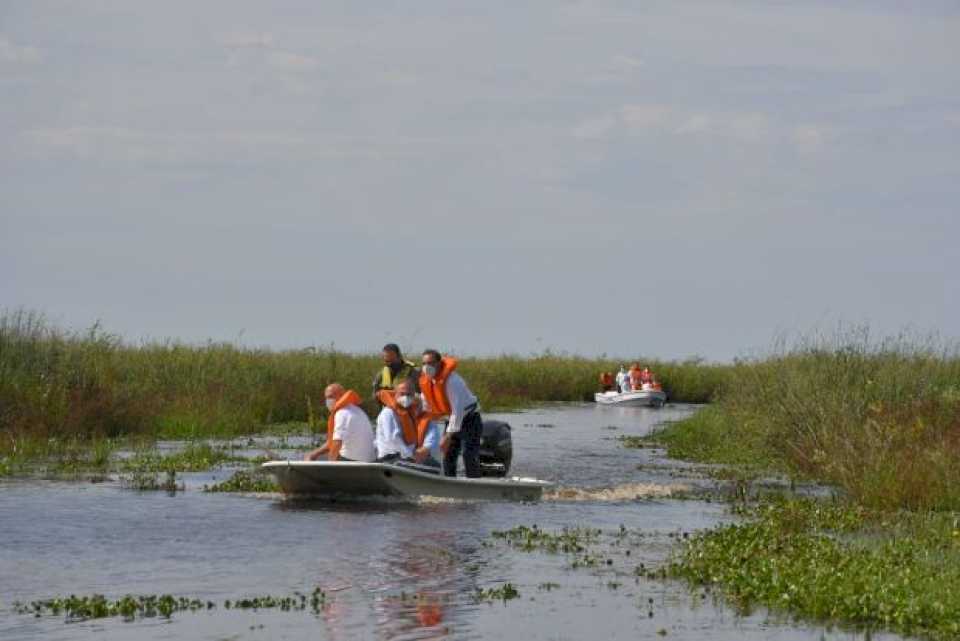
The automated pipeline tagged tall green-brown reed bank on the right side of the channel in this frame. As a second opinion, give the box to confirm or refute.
[655,330,960,509]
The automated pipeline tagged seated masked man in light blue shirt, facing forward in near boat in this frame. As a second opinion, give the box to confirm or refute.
[376,381,440,467]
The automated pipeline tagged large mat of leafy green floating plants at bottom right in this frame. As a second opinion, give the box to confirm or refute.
[669,499,960,639]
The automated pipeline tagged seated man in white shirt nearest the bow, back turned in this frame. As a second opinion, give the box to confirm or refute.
[304,383,376,463]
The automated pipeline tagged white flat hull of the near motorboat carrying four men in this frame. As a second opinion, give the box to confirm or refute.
[262,461,553,501]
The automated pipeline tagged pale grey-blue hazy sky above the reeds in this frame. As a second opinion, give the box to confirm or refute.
[0,0,960,361]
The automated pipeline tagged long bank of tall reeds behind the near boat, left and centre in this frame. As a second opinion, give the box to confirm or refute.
[0,311,728,461]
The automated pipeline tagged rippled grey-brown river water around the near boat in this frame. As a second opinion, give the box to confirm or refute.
[0,405,900,640]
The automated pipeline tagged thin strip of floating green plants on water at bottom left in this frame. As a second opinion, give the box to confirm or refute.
[13,584,330,623]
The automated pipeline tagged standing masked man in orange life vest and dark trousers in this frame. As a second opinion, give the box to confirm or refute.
[420,349,483,478]
